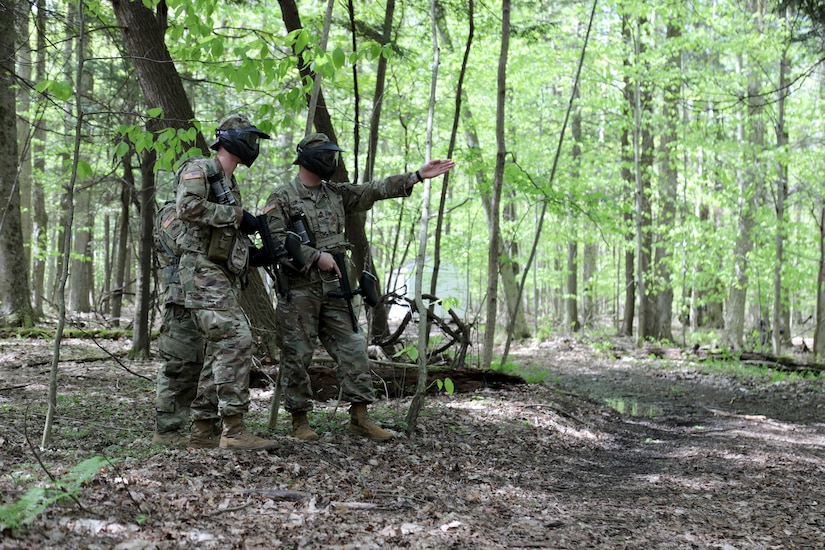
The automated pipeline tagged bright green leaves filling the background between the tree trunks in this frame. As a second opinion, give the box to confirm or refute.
[12,0,823,350]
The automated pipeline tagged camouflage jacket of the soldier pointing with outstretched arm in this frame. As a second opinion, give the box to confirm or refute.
[264,173,418,288]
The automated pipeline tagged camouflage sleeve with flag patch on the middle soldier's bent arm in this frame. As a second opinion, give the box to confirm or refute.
[176,159,239,228]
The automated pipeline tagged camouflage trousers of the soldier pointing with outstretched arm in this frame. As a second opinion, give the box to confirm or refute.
[275,280,375,412]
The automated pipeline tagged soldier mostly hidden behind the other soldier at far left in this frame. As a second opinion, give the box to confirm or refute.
[152,201,208,446]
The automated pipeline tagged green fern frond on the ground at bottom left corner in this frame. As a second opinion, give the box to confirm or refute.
[0,456,108,531]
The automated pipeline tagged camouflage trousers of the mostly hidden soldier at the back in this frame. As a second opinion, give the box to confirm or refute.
[155,303,203,433]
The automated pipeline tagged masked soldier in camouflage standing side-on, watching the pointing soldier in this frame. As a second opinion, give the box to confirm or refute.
[176,115,276,449]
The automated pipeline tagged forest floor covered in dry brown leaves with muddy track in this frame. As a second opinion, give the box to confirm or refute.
[0,338,825,550]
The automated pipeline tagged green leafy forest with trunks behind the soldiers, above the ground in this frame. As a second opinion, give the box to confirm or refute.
[0,0,825,363]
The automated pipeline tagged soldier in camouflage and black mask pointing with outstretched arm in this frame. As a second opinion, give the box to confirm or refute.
[264,133,454,440]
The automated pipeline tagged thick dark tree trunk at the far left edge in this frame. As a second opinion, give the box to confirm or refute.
[0,2,34,327]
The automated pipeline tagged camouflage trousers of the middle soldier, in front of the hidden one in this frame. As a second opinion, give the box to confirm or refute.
[192,299,252,420]
